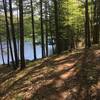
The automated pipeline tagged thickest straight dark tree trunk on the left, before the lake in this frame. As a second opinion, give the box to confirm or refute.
[19,0,25,69]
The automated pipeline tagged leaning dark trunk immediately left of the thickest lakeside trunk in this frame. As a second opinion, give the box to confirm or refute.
[9,0,19,68]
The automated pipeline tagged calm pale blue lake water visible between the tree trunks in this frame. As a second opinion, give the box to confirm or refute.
[0,41,53,64]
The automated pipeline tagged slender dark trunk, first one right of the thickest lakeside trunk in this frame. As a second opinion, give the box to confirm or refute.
[30,0,36,60]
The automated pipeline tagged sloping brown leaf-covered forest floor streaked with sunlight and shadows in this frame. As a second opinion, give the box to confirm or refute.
[0,46,100,100]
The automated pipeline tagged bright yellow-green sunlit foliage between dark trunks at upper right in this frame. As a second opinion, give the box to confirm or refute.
[60,0,84,35]
